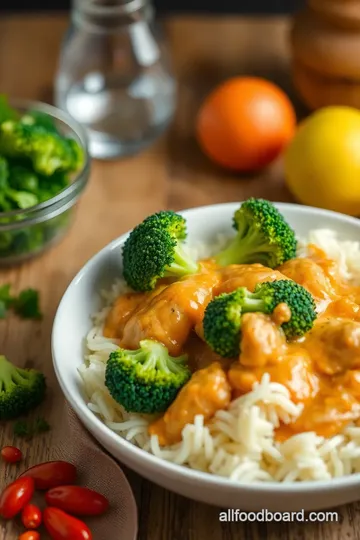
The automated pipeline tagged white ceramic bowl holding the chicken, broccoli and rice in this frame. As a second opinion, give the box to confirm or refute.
[52,203,360,511]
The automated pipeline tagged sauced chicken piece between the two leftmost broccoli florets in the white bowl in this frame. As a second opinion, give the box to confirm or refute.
[121,272,219,356]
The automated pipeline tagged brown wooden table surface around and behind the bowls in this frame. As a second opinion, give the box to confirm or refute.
[0,11,360,540]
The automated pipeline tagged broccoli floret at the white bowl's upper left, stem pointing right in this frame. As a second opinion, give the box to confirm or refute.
[123,211,198,291]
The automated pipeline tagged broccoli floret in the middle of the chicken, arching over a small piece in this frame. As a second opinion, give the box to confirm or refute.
[203,280,316,358]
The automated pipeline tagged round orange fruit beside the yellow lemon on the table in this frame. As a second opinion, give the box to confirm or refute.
[196,77,296,172]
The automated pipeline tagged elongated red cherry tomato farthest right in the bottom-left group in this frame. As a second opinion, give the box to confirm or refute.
[45,486,109,516]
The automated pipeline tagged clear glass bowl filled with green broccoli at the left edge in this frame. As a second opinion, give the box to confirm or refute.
[0,96,90,266]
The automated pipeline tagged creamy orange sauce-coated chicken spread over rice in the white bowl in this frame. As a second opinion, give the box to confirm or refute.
[104,246,360,445]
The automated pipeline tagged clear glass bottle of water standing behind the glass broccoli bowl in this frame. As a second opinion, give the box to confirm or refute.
[55,0,176,159]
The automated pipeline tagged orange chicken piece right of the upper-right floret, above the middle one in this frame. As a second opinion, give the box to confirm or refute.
[278,258,336,313]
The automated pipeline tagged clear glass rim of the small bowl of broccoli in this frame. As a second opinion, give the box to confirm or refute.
[0,98,91,221]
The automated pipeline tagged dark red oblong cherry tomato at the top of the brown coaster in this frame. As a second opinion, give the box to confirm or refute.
[21,461,76,490]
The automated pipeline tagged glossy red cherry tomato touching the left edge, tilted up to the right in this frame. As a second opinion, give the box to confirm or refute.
[0,476,35,519]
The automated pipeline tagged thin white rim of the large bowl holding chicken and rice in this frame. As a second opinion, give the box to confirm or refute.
[51,201,360,494]
